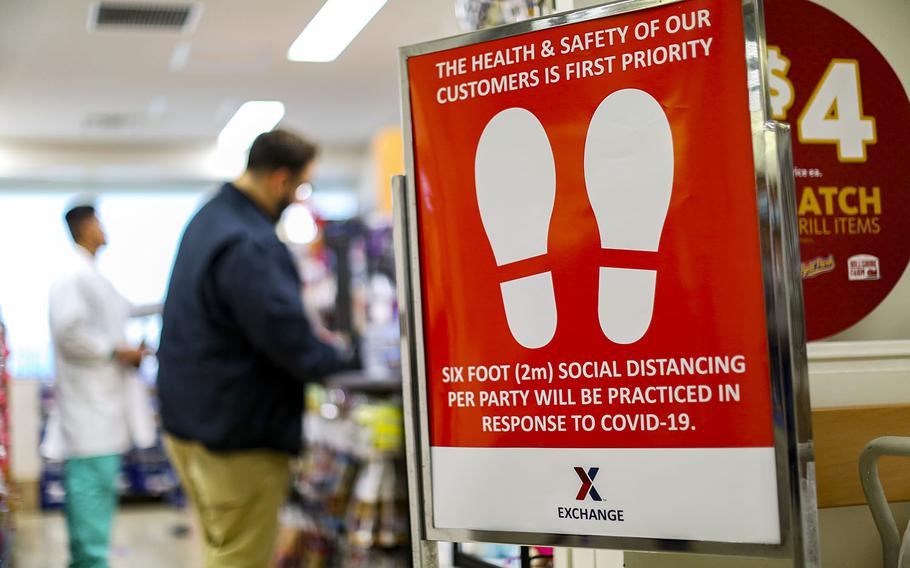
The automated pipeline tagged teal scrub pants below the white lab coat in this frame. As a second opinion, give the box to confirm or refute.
[64,455,120,568]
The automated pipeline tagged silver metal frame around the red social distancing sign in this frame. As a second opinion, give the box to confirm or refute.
[393,0,818,567]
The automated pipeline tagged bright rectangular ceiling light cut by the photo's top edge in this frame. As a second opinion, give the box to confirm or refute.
[288,0,387,62]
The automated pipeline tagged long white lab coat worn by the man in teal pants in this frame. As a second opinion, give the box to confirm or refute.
[42,246,155,459]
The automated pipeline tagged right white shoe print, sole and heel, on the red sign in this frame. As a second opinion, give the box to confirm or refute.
[585,89,673,344]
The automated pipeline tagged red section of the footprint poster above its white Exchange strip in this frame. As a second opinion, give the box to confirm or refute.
[409,2,773,447]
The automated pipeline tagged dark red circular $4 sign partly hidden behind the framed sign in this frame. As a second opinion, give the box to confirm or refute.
[765,0,910,340]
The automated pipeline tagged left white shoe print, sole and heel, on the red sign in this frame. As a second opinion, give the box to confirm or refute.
[474,104,556,349]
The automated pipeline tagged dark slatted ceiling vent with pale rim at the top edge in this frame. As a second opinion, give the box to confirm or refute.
[89,2,201,33]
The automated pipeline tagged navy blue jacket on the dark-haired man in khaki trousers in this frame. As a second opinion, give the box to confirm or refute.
[158,184,340,453]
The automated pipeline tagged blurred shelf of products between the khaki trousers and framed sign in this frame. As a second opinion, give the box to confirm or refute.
[274,379,410,568]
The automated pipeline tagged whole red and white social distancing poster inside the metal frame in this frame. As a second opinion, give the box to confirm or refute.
[407,0,779,542]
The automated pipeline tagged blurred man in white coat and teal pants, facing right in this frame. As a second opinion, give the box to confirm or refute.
[49,205,145,568]
